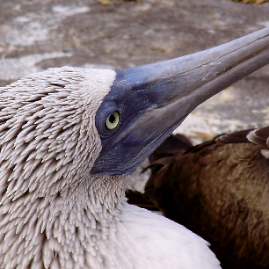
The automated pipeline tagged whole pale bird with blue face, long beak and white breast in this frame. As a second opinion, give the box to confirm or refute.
[0,25,269,269]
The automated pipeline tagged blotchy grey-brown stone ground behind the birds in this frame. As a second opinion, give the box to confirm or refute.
[0,0,269,189]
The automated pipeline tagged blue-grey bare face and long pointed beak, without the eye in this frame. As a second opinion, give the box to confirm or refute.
[92,27,269,174]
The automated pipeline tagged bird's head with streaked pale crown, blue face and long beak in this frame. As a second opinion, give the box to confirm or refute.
[0,28,269,199]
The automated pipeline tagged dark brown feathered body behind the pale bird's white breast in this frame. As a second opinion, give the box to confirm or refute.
[129,127,269,268]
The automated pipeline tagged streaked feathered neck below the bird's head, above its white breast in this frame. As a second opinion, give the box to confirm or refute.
[0,172,126,268]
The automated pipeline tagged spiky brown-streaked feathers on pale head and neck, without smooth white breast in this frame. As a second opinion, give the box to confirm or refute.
[0,65,131,269]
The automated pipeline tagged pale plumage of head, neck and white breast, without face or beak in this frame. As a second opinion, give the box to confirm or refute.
[0,67,219,269]
